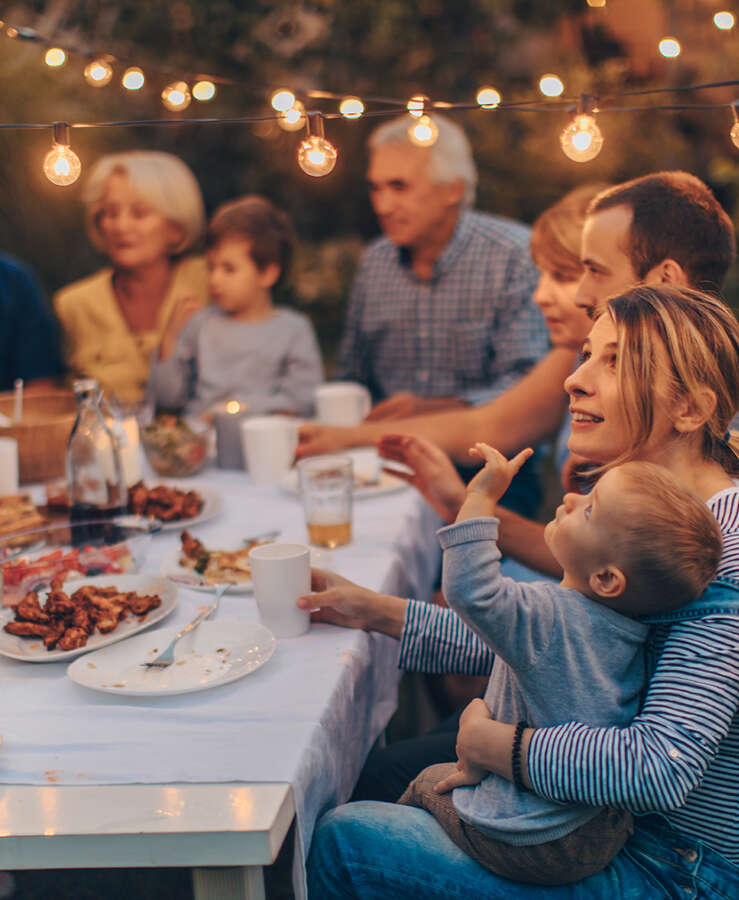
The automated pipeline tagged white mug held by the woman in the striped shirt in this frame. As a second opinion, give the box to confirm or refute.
[249,544,310,637]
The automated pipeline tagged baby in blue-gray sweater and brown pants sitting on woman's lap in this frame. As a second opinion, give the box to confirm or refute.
[399,444,721,885]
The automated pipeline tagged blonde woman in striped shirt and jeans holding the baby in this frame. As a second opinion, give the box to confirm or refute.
[310,285,739,900]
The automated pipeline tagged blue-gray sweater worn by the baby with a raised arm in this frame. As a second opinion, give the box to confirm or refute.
[438,518,648,846]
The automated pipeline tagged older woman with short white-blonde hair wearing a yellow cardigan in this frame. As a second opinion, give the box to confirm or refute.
[54,151,208,403]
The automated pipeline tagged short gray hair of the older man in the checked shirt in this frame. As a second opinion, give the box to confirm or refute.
[367,113,477,209]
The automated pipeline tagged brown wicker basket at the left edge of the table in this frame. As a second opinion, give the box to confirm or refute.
[0,391,76,484]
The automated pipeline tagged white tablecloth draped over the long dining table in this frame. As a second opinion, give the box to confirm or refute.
[0,470,439,895]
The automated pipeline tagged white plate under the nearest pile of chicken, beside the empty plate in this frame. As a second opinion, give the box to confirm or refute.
[0,575,177,662]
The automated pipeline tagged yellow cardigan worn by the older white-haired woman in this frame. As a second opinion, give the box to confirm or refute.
[54,256,208,403]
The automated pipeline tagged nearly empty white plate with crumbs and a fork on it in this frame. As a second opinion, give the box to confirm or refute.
[67,621,275,697]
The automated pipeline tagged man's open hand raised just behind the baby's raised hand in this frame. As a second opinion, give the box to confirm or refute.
[377,434,465,522]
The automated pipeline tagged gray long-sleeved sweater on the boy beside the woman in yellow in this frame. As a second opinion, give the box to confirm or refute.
[147,306,323,416]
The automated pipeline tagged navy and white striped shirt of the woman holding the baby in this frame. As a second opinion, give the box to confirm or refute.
[399,487,739,863]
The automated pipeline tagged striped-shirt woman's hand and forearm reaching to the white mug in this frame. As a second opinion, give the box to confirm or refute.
[297,569,408,637]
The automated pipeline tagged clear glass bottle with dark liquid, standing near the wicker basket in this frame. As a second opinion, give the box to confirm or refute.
[67,378,128,542]
